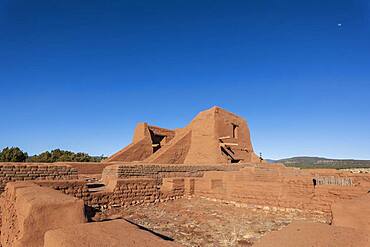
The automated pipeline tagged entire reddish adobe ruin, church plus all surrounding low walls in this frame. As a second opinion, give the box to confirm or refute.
[0,107,370,247]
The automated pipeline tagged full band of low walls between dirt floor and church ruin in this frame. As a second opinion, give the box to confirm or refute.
[1,163,370,220]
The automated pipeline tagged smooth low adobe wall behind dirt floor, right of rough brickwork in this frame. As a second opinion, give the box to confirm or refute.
[194,164,370,214]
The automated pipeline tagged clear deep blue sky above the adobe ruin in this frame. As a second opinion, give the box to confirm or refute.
[0,0,370,159]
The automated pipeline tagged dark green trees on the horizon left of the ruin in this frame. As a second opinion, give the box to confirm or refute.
[0,147,106,163]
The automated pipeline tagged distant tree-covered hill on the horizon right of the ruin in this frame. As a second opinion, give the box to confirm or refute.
[267,156,370,169]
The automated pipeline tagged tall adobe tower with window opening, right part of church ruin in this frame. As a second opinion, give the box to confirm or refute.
[184,107,258,164]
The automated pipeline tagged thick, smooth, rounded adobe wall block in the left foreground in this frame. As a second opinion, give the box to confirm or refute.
[1,182,86,247]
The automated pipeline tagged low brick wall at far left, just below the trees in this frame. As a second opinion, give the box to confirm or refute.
[0,162,77,193]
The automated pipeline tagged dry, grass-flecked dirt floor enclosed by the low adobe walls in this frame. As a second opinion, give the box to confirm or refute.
[94,198,327,246]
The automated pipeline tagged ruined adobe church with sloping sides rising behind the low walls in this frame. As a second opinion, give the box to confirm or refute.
[106,107,259,164]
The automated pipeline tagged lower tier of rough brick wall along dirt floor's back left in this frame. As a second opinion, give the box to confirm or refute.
[35,178,192,208]
